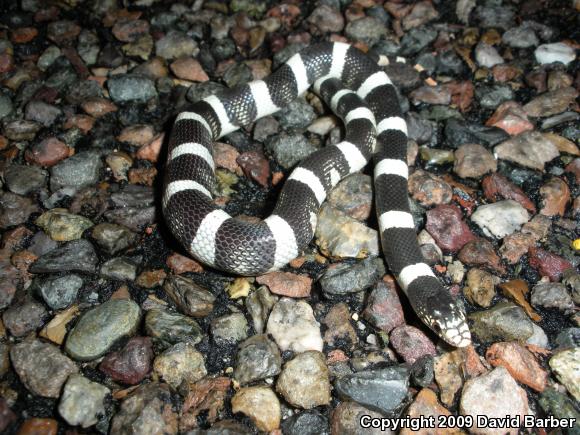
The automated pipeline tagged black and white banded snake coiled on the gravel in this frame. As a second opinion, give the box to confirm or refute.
[161,42,471,347]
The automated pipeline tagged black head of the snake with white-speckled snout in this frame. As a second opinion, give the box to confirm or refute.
[408,280,471,347]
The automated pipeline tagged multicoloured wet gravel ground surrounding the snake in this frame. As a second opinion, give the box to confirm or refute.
[0,0,580,435]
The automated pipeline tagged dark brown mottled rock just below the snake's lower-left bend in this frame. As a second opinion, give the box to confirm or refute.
[163,275,215,317]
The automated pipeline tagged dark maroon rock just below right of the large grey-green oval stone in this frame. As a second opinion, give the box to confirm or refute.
[99,337,154,385]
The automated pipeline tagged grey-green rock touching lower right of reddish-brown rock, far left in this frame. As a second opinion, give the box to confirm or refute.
[50,151,103,192]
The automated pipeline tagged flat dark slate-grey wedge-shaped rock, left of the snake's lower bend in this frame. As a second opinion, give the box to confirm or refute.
[28,239,98,273]
